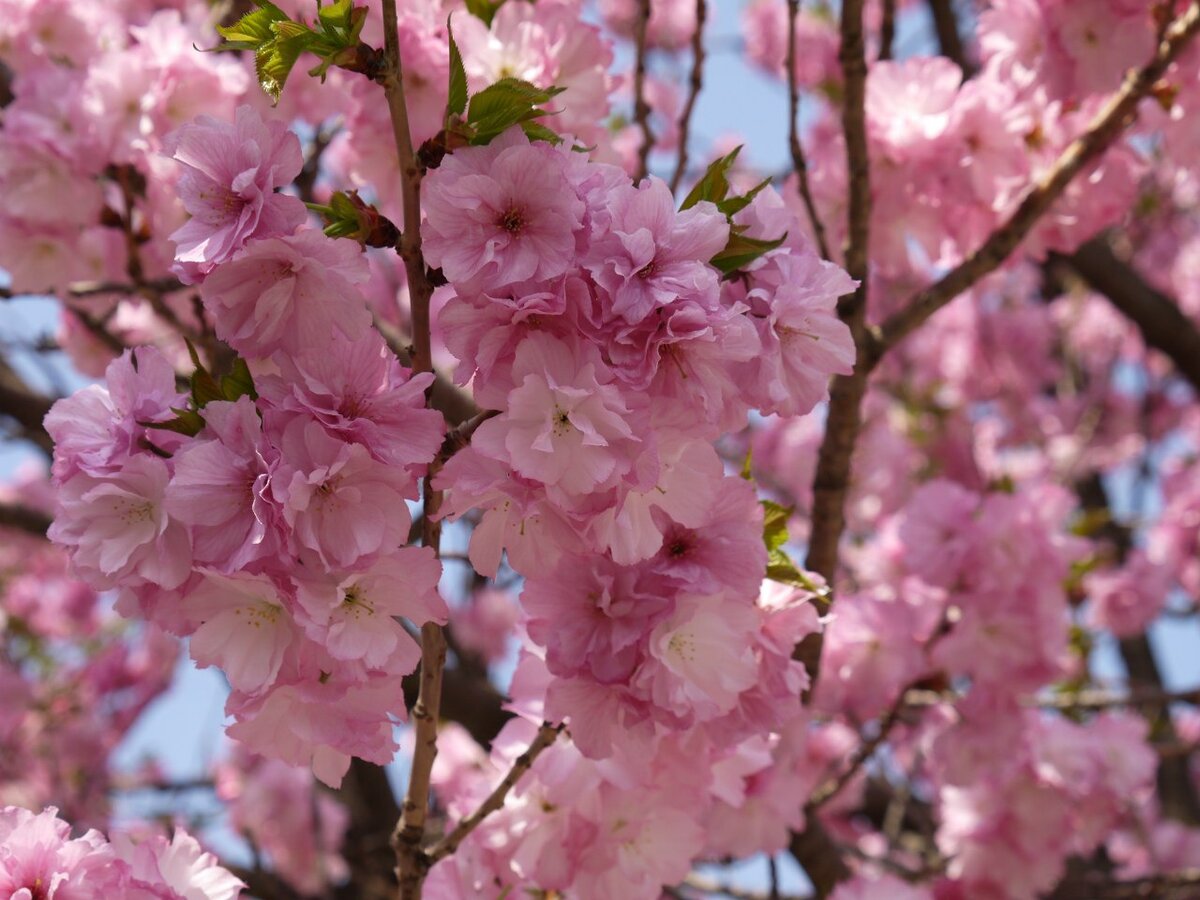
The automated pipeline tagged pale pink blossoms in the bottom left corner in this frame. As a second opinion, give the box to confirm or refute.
[0,806,245,900]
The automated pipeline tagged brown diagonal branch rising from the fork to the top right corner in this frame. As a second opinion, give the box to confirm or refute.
[872,2,1200,358]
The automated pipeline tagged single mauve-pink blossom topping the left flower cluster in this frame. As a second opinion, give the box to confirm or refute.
[166,107,306,281]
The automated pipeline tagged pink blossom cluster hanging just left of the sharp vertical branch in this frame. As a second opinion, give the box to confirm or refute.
[47,109,446,784]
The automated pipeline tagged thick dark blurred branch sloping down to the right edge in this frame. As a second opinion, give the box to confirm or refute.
[1064,236,1200,394]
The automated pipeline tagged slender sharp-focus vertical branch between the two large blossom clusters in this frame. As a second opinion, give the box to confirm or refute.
[380,0,446,900]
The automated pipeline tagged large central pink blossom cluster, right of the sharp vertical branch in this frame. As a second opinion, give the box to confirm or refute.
[424,131,853,898]
